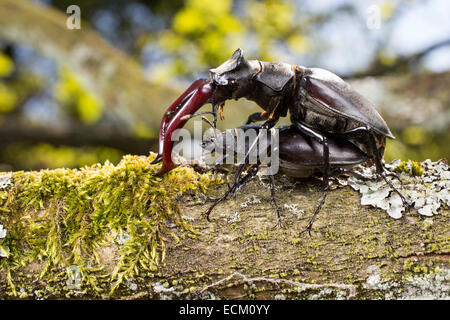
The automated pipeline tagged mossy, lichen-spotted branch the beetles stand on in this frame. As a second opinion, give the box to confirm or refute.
[0,155,450,299]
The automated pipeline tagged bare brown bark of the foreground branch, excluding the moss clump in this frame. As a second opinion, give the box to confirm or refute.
[0,158,450,299]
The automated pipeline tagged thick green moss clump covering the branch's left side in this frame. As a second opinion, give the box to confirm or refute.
[0,155,221,295]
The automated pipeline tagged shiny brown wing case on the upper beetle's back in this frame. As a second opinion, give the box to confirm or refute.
[305,68,395,139]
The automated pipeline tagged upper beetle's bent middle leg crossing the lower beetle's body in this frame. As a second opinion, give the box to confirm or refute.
[295,122,330,235]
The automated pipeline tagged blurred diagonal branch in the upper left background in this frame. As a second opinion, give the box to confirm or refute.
[0,0,178,129]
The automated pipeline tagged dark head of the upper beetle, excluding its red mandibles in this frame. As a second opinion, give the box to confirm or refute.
[209,48,260,99]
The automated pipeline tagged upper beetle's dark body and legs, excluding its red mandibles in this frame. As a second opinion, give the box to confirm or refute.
[210,49,408,207]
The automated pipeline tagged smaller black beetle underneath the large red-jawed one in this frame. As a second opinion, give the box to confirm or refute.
[203,125,369,231]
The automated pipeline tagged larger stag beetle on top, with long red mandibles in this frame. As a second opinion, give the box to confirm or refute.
[153,49,408,230]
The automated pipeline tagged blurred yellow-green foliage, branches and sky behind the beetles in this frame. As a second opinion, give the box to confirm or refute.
[0,0,450,171]
